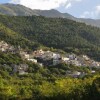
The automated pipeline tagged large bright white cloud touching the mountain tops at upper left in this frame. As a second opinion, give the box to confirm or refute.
[10,0,82,10]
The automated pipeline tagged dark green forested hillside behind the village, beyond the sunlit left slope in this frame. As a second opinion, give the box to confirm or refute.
[0,16,100,60]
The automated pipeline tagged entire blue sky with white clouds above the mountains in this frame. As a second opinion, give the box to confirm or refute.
[0,0,100,19]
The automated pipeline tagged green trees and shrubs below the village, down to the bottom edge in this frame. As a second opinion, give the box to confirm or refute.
[0,53,100,100]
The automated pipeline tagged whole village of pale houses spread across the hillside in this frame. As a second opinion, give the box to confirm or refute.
[0,41,100,75]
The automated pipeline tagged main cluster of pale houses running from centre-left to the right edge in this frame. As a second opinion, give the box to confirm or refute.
[20,49,100,68]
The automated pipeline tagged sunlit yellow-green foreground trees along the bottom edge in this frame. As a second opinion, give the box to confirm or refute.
[0,71,100,100]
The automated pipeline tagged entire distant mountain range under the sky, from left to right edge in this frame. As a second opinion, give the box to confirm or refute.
[0,3,100,27]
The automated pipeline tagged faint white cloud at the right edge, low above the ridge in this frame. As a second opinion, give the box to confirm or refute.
[80,5,100,19]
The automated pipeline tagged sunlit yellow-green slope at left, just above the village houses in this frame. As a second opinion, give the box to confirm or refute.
[0,23,39,50]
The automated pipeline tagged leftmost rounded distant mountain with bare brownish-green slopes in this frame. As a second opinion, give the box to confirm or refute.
[0,4,37,16]
